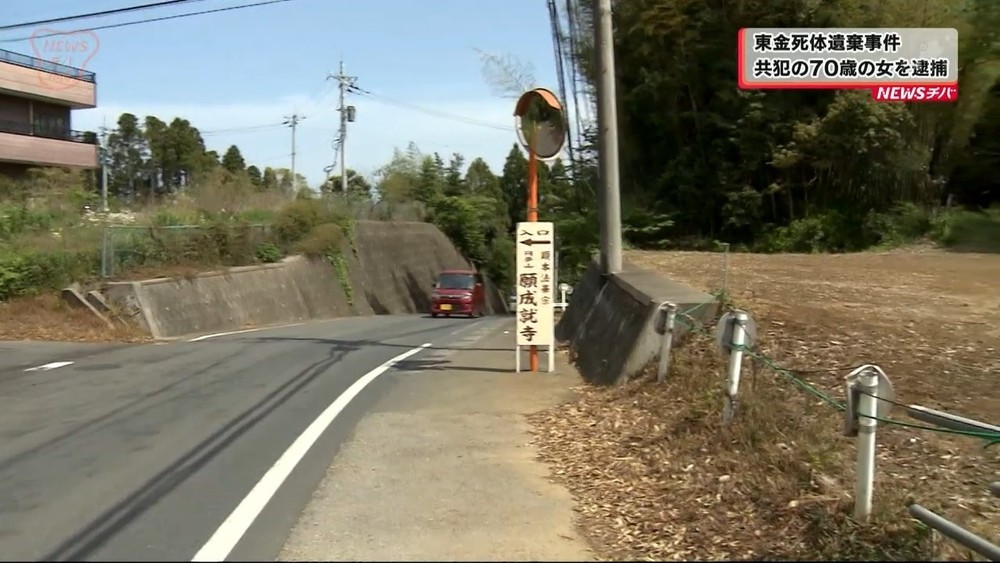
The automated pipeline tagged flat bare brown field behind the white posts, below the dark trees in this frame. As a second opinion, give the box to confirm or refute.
[628,250,1000,422]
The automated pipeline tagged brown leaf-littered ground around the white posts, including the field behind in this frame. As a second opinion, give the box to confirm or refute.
[532,250,1000,560]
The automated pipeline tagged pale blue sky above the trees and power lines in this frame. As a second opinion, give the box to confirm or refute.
[0,0,572,186]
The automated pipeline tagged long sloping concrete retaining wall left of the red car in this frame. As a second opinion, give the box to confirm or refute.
[104,221,506,338]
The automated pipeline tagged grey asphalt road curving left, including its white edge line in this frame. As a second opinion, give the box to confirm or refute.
[0,316,503,561]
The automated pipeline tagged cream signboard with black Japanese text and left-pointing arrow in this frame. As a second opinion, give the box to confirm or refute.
[516,223,555,346]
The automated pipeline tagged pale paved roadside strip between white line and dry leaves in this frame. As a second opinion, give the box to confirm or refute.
[279,319,594,562]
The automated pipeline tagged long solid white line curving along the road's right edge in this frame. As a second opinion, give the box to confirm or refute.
[191,342,431,561]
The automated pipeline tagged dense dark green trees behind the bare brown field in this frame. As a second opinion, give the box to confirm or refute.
[573,0,1000,250]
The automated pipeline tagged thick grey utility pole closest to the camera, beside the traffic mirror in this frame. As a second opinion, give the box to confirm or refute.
[594,0,622,275]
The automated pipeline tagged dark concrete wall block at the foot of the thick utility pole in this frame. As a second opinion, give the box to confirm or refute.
[556,262,718,385]
